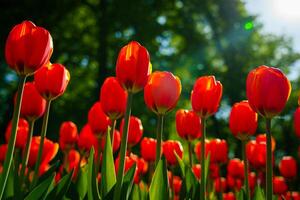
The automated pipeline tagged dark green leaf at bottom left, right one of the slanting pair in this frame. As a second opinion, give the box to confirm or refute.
[47,170,74,200]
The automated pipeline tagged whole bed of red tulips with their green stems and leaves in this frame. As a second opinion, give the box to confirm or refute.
[0,21,300,200]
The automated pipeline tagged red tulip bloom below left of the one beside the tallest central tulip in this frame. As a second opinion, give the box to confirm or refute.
[88,102,111,138]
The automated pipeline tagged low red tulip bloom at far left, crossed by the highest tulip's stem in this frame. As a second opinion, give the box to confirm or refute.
[5,118,29,149]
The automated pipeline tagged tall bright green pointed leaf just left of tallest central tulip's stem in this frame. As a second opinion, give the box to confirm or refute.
[101,133,116,197]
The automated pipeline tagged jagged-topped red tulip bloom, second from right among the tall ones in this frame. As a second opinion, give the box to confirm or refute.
[191,76,223,118]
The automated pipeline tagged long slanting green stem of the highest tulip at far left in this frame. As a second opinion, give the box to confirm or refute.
[0,75,26,199]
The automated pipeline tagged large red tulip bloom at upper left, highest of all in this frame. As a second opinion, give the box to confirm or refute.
[5,21,53,75]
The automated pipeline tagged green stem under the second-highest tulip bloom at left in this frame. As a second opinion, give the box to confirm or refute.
[31,100,51,190]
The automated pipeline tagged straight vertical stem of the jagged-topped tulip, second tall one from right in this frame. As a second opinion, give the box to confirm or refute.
[200,117,206,200]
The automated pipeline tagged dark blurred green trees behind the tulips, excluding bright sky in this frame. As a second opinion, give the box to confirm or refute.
[0,0,300,189]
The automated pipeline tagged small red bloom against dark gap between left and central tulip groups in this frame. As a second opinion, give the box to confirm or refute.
[59,121,78,151]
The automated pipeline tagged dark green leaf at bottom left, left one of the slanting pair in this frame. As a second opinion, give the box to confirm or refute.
[25,173,55,200]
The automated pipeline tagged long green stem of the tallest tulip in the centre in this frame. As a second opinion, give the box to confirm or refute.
[114,91,133,200]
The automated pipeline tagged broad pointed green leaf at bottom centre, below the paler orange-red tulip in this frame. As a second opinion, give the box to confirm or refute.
[149,157,169,200]
